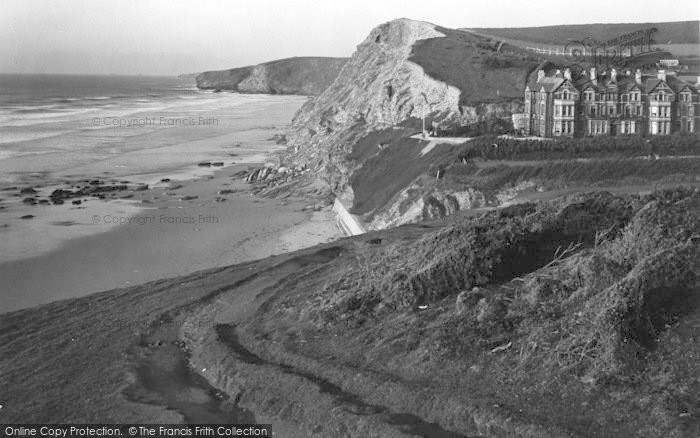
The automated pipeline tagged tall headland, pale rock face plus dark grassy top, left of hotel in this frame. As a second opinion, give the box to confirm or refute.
[288,19,534,222]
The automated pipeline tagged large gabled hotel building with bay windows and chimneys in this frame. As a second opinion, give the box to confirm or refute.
[523,68,700,137]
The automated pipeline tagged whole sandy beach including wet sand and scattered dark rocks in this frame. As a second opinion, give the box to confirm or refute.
[0,96,341,313]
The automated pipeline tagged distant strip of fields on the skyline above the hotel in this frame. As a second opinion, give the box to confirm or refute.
[470,21,700,45]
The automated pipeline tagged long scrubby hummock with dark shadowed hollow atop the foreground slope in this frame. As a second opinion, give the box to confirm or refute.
[325,193,644,319]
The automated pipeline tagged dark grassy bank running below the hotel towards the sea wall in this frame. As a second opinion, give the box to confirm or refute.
[348,127,700,215]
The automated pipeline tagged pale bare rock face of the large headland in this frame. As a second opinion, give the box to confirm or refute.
[289,20,460,173]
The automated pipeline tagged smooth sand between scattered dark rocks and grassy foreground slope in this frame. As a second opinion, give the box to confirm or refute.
[0,159,342,313]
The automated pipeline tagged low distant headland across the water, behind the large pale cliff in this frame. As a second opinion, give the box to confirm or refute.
[196,57,347,96]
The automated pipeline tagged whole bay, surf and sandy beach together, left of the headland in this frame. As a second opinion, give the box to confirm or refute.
[0,75,340,313]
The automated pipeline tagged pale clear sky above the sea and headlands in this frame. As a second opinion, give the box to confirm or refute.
[0,0,700,75]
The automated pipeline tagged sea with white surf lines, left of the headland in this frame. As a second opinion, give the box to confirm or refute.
[0,74,304,185]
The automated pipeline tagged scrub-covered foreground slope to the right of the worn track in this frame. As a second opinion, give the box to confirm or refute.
[239,189,700,437]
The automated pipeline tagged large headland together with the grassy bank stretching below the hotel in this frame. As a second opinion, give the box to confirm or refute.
[239,19,699,230]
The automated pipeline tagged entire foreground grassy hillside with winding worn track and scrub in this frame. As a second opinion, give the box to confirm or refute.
[0,190,700,438]
